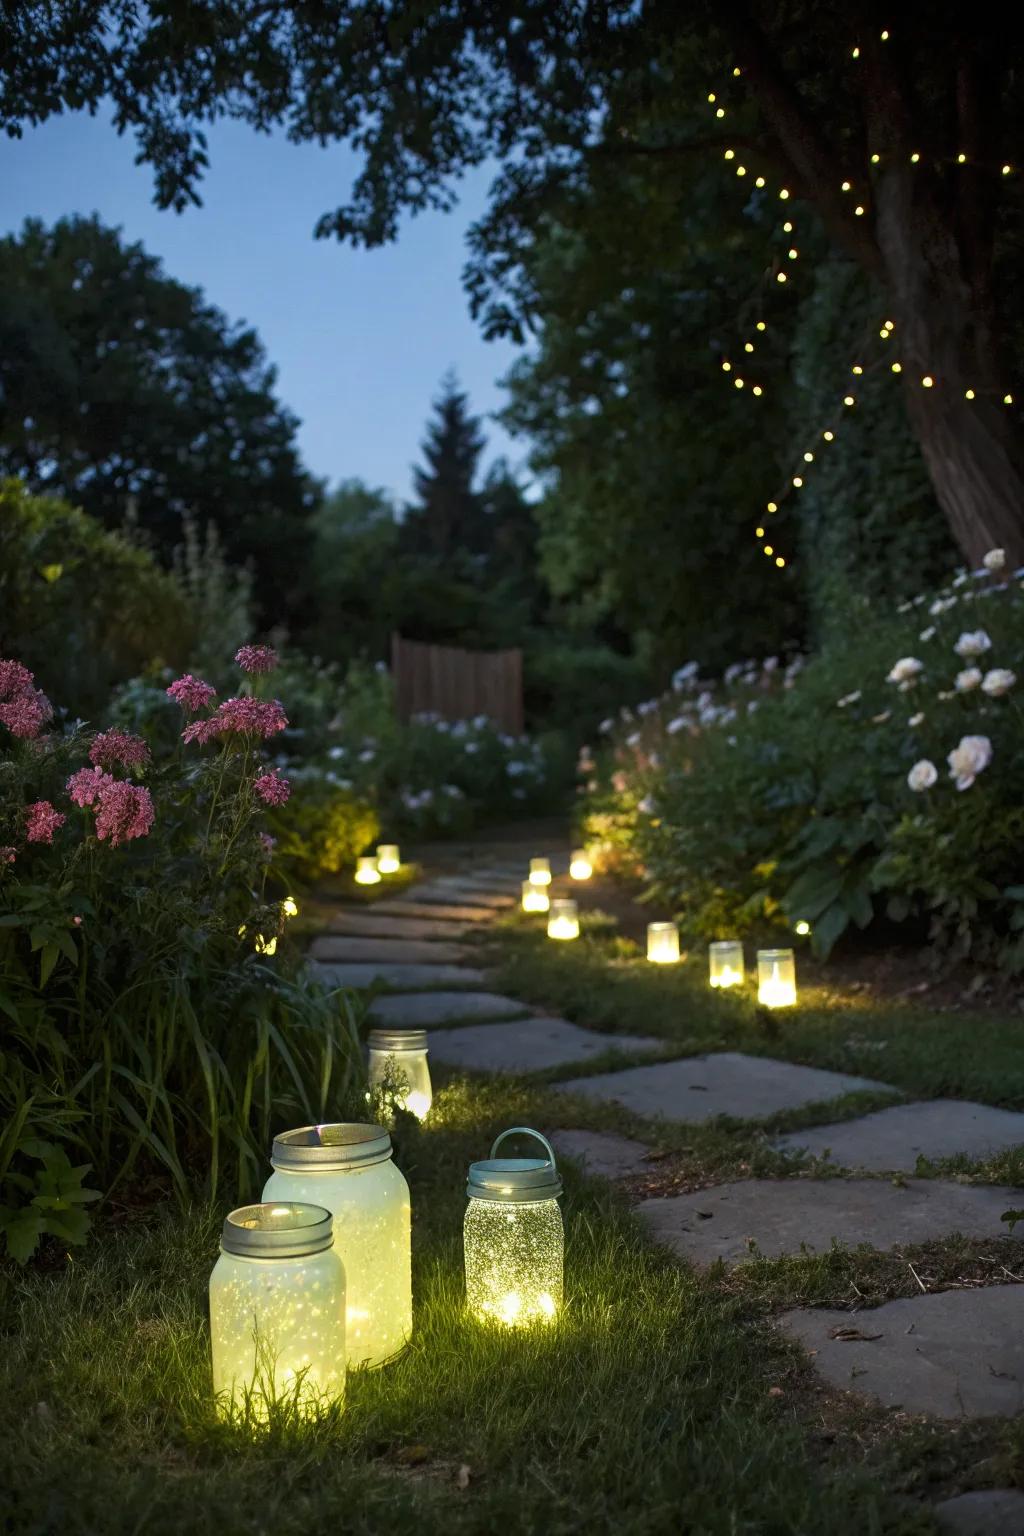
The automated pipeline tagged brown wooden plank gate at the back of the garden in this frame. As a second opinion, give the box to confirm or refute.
[391,634,522,736]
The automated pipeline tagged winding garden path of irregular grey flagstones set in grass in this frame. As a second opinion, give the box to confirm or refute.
[312,848,1024,1511]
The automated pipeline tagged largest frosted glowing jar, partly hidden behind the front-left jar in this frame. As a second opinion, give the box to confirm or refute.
[263,1124,413,1369]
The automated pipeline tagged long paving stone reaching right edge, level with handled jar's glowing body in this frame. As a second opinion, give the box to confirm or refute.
[637,1178,1019,1264]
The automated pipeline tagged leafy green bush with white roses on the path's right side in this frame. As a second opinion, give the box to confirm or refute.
[579,550,1024,971]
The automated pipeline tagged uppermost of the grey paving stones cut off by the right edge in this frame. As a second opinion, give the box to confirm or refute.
[777,1098,1024,1174]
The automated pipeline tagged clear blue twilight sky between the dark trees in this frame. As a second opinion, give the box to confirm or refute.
[0,114,527,498]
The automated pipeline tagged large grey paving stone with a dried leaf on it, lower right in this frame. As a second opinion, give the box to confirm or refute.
[780,1286,1024,1419]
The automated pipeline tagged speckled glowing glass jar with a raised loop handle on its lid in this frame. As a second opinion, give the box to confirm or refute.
[464,1126,565,1327]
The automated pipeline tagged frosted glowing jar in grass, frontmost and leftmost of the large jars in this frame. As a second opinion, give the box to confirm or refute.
[210,1201,345,1424]
